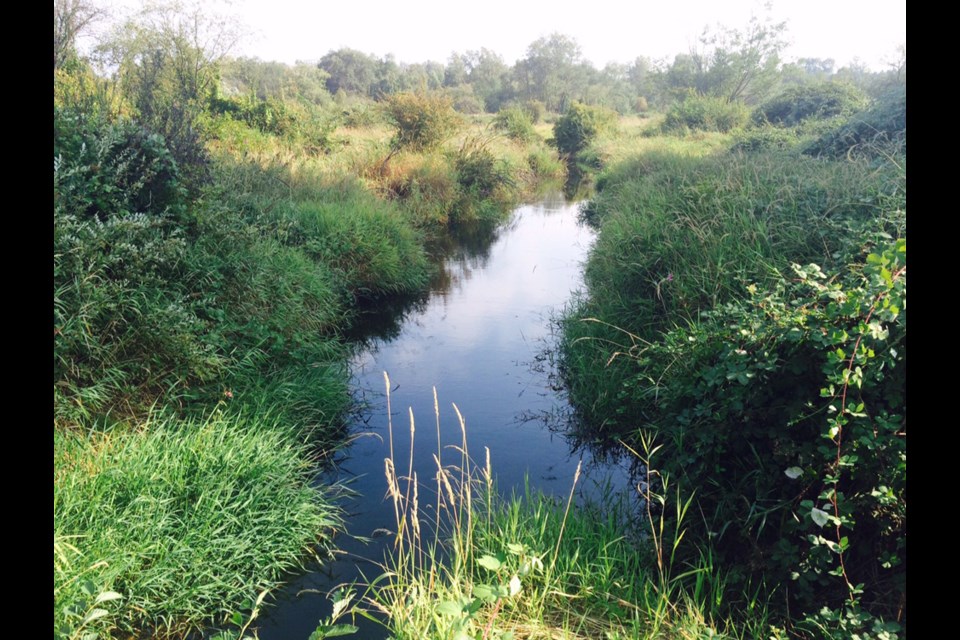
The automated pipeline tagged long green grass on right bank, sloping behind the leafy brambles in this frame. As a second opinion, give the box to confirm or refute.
[563,146,906,430]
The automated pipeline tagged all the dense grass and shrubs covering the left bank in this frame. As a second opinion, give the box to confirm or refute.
[53,58,563,638]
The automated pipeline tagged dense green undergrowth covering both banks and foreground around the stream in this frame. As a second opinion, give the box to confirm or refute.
[53,13,906,640]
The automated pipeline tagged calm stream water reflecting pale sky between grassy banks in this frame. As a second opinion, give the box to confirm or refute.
[258,194,627,640]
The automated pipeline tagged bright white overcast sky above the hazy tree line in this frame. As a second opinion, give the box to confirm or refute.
[103,0,906,70]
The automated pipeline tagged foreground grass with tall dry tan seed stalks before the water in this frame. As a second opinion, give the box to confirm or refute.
[352,374,768,640]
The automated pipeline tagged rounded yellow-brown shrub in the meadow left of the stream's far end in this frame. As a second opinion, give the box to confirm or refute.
[383,92,461,150]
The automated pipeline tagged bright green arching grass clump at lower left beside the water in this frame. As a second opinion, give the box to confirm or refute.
[53,411,340,637]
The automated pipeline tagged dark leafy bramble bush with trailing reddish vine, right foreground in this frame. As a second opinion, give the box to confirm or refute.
[612,241,906,632]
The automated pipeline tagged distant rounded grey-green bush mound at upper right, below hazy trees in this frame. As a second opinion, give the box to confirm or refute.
[752,82,867,127]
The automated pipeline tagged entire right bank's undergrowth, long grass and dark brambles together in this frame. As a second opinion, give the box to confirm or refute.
[563,90,906,637]
